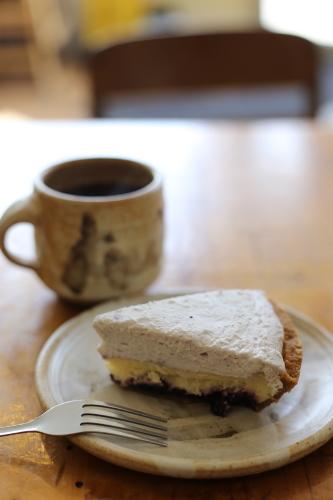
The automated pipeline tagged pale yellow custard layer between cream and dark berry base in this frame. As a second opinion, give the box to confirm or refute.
[106,358,275,403]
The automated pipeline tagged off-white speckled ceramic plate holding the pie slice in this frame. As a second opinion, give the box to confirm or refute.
[36,295,333,478]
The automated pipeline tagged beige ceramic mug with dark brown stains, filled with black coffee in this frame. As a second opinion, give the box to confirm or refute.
[0,158,163,302]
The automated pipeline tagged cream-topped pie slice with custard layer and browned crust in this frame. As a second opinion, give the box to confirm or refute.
[94,290,302,415]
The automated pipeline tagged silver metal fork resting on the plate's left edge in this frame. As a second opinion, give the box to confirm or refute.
[0,400,167,446]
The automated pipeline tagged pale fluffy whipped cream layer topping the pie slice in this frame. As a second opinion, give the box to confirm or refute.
[94,290,285,392]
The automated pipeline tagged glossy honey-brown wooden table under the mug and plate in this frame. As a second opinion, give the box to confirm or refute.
[0,121,333,500]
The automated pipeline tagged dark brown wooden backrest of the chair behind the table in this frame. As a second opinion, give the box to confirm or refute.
[89,31,317,116]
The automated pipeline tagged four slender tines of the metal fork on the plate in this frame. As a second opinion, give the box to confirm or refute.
[80,401,167,446]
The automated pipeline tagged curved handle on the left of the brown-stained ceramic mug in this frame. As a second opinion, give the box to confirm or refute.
[0,196,39,272]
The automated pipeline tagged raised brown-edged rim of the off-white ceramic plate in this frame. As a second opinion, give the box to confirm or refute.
[35,289,333,479]
